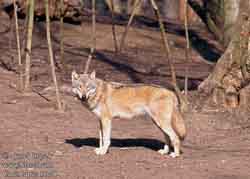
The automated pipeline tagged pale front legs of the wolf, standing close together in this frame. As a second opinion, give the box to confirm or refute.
[95,118,111,155]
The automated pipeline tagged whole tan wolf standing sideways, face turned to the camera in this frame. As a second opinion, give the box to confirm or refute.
[72,71,186,157]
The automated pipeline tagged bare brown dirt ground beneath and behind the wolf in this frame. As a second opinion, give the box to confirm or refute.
[0,14,250,179]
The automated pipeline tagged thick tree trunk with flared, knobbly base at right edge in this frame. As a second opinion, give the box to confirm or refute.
[199,0,250,107]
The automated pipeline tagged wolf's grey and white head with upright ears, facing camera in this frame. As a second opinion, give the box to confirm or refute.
[72,71,97,99]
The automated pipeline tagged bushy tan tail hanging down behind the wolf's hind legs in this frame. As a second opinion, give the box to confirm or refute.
[171,107,187,140]
